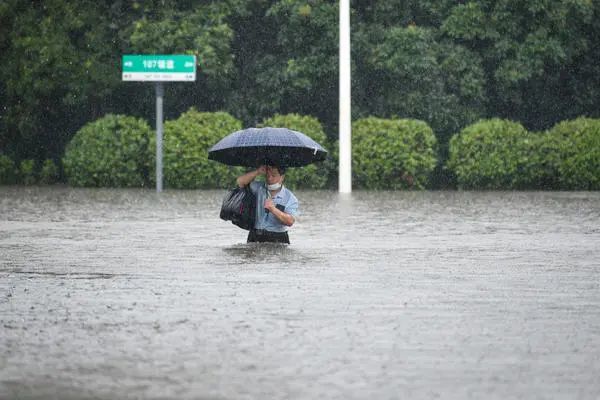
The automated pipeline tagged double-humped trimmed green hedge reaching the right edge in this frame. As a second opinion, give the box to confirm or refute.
[447,118,600,190]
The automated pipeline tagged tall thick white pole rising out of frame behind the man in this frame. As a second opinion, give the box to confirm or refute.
[339,0,352,193]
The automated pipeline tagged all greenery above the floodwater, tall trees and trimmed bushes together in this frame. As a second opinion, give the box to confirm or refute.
[0,0,600,190]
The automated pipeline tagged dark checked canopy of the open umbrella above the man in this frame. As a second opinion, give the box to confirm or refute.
[208,127,327,167]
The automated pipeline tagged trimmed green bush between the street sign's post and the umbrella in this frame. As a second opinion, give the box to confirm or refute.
[148,108,243,189]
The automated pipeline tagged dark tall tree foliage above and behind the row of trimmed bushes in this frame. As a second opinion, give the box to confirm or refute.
[0,0,600,189]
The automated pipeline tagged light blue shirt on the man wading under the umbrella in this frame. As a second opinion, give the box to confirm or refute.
[250,181,299,232]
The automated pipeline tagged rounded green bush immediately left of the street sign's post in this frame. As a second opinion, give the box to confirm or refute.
[63,114,152,187]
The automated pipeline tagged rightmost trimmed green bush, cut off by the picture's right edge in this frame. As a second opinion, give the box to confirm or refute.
[548,117,600,190]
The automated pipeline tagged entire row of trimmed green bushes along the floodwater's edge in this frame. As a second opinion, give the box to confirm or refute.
[52,109,600,190]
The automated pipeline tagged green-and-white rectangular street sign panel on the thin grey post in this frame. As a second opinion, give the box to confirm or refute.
[123,54,196,82]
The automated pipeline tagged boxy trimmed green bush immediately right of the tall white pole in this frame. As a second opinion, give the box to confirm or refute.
[352,117,437,190]
